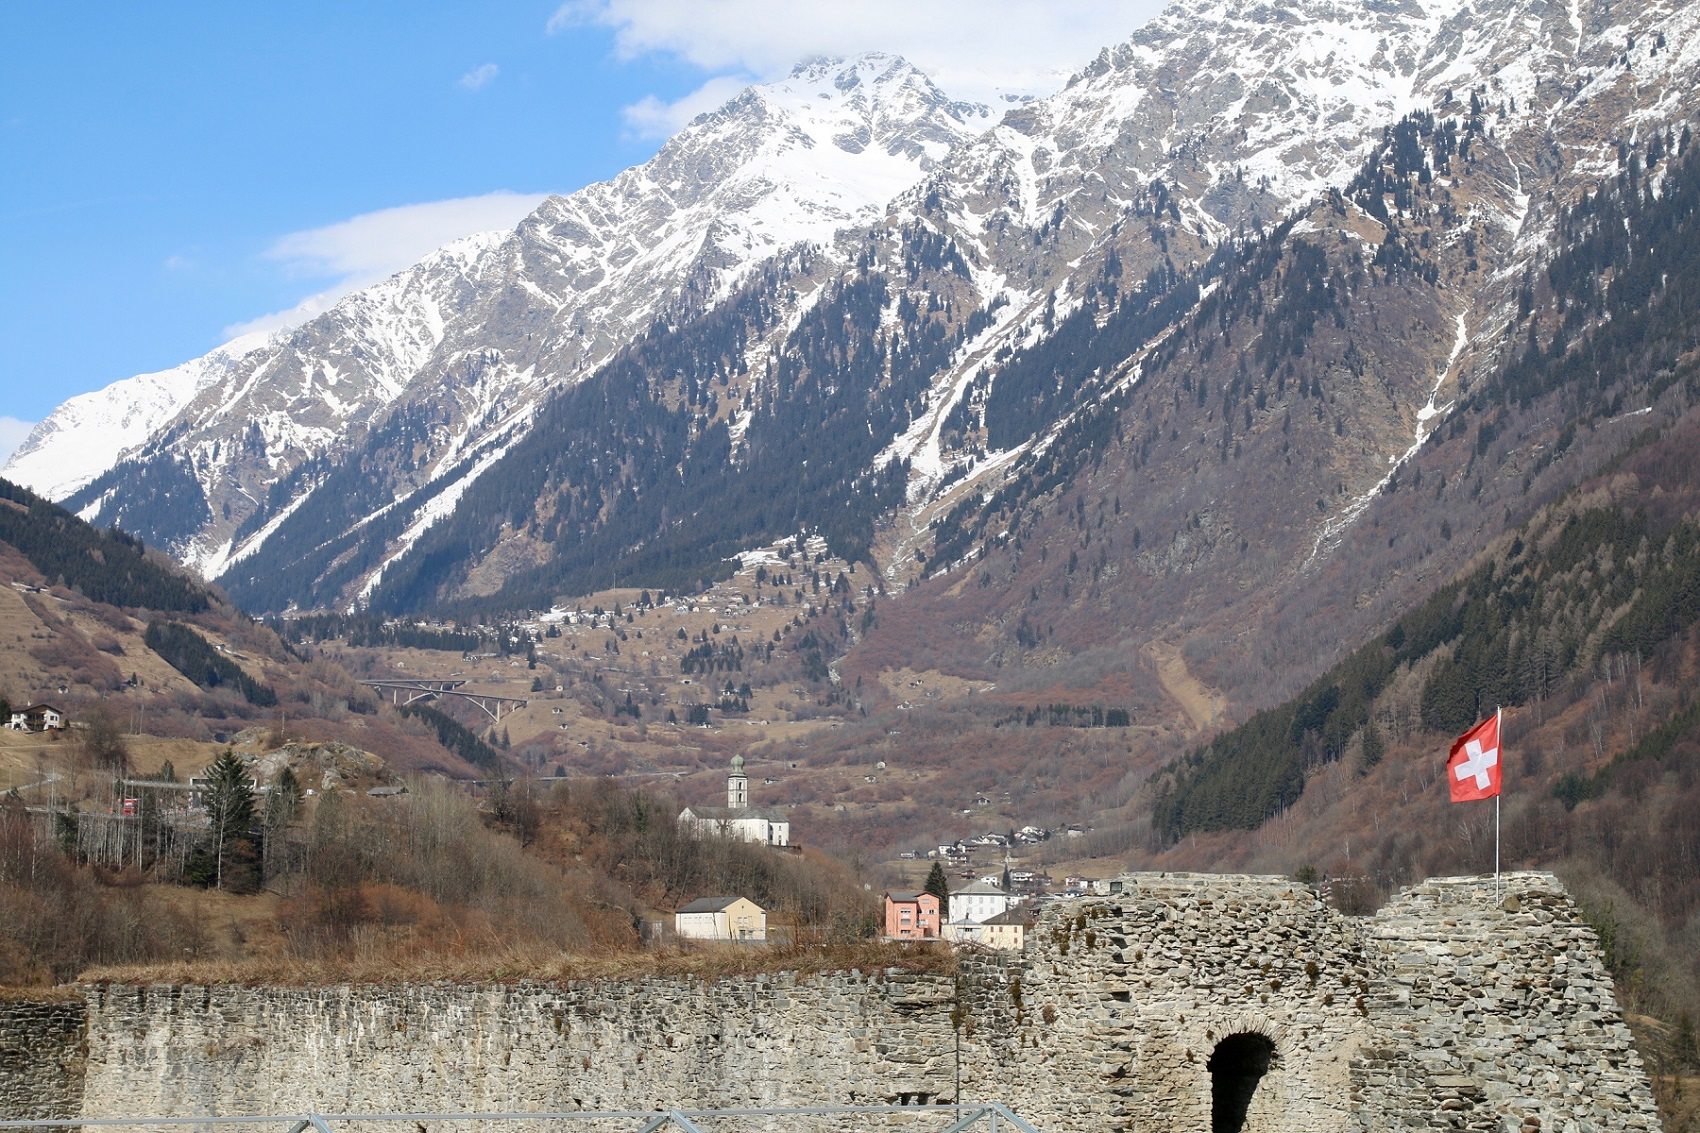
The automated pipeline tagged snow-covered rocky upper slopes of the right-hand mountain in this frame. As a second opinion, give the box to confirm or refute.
[843,0,1700,595]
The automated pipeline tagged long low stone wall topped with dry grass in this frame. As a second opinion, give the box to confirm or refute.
[69,973,954,1116]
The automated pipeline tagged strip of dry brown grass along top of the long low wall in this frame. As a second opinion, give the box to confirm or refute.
[82,942,957,987]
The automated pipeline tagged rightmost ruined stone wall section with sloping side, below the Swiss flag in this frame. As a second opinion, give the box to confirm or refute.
[1352,873,1659,1133]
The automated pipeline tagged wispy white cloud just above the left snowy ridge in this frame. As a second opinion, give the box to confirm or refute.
[224,191,547,339]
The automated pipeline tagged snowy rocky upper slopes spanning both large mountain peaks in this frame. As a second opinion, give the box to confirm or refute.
[26,0,1695,619]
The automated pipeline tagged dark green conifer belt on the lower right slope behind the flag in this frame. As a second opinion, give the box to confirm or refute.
[1154,509,1700,840]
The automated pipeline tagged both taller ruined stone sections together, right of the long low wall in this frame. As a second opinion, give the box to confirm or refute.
[964,873,1659,1133]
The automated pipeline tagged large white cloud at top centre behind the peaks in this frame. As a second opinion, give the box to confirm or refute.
[549,0,1165,114]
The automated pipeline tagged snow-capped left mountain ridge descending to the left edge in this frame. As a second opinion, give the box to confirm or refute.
[5,54,991,577]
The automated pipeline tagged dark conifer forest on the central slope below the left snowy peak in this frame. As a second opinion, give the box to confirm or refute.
[224,228,989,614]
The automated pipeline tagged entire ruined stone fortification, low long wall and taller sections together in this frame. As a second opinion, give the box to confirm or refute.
[0,874,1658,1133]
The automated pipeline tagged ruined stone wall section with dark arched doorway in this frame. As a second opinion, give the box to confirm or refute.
[964,874,1372,1133]
